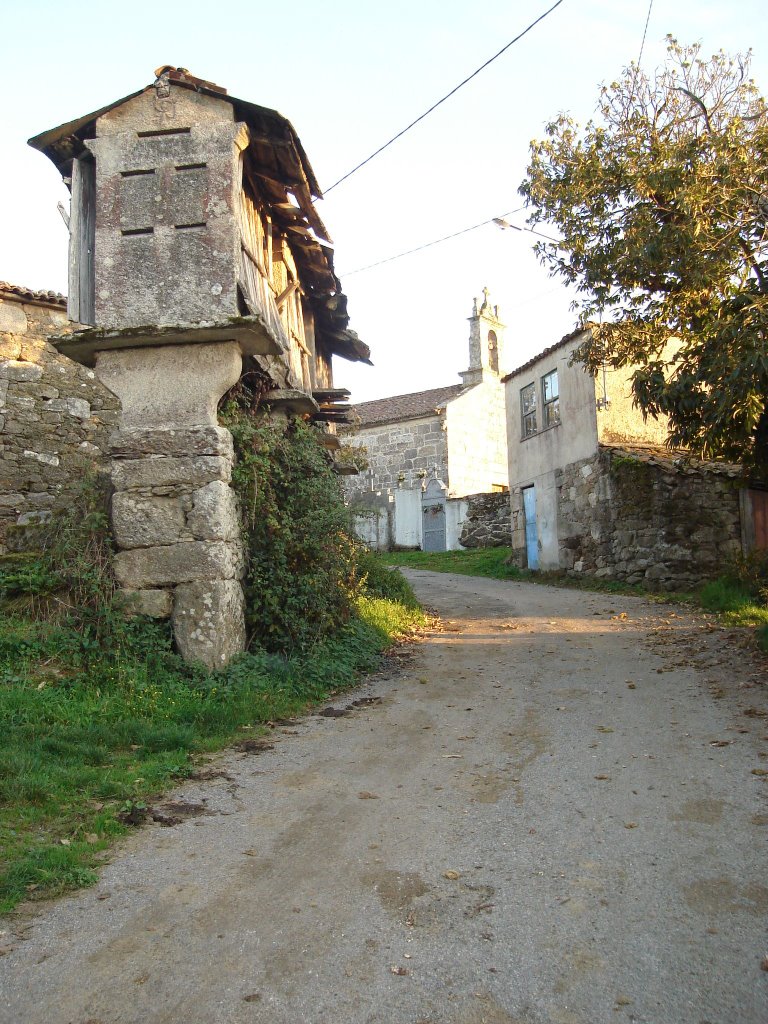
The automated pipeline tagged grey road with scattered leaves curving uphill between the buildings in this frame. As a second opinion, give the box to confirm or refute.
[0,572,768,1024]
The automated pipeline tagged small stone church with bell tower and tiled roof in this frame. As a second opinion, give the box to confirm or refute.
[344,290,508,550]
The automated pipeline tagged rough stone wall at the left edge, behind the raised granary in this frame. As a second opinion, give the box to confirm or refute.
[0,289,119,553]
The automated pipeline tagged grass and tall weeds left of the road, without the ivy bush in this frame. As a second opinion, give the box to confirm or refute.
[0,464,422,912]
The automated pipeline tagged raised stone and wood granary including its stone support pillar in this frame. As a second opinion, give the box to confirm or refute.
[31,67,369,668]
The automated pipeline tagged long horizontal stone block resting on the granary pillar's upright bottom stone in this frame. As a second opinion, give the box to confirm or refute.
[115,541,243,590]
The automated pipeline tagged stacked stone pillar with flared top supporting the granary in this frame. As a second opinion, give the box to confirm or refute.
[95,341,245,669]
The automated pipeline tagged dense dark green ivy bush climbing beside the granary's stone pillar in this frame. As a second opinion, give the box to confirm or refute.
[221,392,356,652]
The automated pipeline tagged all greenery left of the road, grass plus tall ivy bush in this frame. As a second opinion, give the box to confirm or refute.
[0,432,424,912]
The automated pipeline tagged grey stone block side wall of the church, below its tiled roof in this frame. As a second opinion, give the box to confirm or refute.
[344,416,447,499]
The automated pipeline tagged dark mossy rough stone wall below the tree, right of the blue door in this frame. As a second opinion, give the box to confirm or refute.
[556,449,741,590]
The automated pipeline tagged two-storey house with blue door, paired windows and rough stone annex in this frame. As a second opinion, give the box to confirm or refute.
[504,331,757,590]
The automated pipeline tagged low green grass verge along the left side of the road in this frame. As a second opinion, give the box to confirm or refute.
[0,573,424,913]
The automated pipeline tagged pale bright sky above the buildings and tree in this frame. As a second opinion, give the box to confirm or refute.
[0,0,768,401]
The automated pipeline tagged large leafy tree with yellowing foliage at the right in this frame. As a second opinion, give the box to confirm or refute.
[520,37,768,474]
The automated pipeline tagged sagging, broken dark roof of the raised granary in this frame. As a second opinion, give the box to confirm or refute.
[29,67,371,364]
